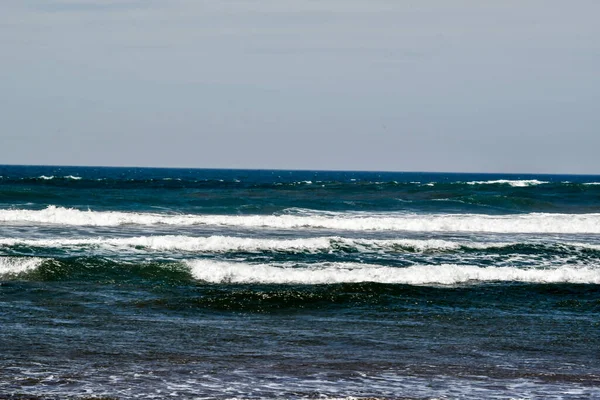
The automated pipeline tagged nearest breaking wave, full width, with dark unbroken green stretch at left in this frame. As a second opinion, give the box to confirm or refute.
[5,257,600,286]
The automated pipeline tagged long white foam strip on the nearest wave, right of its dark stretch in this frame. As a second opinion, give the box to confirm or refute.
[186,260,600,285]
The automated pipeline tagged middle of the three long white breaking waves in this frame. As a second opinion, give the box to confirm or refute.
[0,235,600,253]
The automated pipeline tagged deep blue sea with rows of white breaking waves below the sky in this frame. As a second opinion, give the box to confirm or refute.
[0,166,600,399]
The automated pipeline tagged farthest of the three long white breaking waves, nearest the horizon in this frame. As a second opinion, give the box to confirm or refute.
[0,206,600,234]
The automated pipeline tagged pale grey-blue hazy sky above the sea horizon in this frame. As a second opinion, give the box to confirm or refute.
[0,0,600,174]
